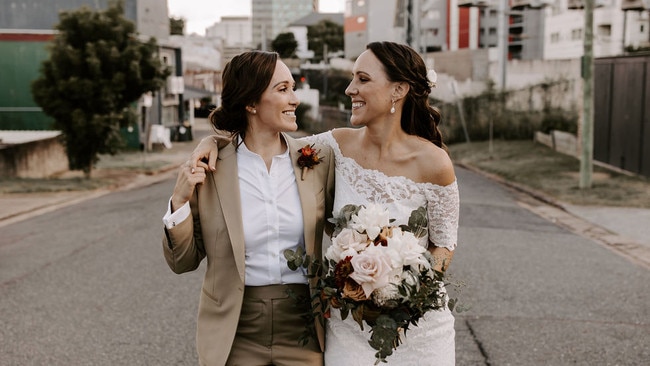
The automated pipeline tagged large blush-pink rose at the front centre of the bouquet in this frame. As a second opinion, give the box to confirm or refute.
[350,245,393,297]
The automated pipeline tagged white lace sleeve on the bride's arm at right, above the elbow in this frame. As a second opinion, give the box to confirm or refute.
[425,181,460,250]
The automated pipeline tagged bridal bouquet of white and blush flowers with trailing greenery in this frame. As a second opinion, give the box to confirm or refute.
[284,205,453,364]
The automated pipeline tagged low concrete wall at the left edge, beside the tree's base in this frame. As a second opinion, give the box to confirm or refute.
[0,137,69,178]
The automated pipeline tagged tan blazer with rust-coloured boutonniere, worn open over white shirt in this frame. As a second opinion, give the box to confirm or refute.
[163,134,334,366]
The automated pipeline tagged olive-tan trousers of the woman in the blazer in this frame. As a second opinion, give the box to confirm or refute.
[226,284,323,366]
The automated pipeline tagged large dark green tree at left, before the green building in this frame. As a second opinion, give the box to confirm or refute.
[31,0,169,178]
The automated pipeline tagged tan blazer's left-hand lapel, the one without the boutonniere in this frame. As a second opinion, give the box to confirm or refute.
[214,144,246,282]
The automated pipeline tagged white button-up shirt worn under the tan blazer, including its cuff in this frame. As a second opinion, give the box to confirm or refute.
[163,143,307,286]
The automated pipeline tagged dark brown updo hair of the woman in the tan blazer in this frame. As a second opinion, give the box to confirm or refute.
[208,51,278,139]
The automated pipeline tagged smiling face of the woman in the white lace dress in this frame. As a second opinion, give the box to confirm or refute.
[345,50,394,126]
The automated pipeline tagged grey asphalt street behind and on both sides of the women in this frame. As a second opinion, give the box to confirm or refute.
[0,164,650,366]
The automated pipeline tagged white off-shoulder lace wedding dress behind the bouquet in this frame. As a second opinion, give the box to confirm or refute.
[306,131,459,366]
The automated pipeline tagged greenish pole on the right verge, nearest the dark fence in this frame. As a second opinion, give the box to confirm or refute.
[579,0,594,189]
